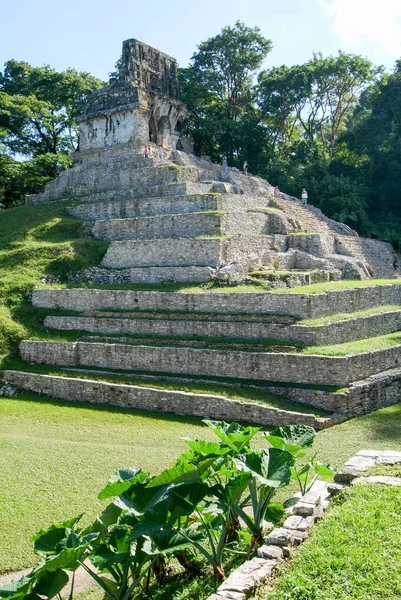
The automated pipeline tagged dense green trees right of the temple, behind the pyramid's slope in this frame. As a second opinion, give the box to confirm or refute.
[180,22,401,244]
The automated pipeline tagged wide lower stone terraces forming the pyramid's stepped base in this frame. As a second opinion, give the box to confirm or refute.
[2,284,401,427]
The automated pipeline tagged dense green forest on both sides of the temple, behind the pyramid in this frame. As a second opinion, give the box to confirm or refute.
[0,21,401,245]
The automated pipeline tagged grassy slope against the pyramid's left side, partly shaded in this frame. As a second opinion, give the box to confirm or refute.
[0,202,108,358]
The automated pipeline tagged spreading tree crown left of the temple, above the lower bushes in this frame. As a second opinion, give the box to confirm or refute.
[0,60,102,158]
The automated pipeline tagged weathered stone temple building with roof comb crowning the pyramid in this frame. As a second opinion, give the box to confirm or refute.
[78,39,191,152]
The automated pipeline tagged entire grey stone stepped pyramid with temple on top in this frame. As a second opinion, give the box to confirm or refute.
[2,39,401,428]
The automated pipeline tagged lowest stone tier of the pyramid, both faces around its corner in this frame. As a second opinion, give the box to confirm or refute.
[0,368,401,422]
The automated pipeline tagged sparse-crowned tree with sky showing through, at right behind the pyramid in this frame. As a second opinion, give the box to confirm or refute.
[259,52,380,165]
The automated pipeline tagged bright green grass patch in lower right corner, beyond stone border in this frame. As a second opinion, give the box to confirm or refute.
[257,485,401,600]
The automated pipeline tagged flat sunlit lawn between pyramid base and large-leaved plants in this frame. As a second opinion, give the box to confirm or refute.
[0,393,401,573]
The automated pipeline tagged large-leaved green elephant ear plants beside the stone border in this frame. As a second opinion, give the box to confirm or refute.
[0,421,331,600]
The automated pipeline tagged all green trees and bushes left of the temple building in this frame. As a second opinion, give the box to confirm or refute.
[0,60,102,205]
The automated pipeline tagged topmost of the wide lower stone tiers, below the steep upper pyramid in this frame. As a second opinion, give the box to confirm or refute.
[32,284,401,319]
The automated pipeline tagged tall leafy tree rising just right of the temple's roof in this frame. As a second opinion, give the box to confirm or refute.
[180,21,272,167]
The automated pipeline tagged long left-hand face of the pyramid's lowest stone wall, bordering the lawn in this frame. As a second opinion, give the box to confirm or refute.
[0,371,327,429]
